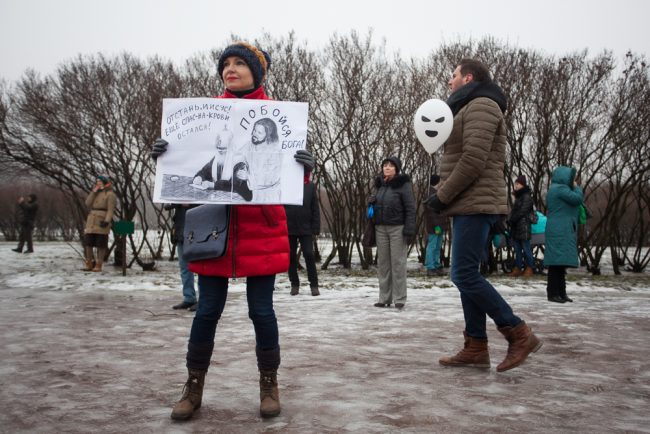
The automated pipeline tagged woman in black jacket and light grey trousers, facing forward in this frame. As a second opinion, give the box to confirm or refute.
[369,157,415,309]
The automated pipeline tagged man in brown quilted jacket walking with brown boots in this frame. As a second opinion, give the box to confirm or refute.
[427,59,542,372]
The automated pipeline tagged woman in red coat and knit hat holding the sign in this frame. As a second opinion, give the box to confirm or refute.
[151,42,314,420]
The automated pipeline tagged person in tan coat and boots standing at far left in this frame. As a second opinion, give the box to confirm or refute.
[84,175,115,272]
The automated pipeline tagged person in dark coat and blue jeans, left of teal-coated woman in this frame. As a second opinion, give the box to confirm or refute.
[508,175,535,277]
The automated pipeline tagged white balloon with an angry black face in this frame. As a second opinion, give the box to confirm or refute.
[414,99,454,154]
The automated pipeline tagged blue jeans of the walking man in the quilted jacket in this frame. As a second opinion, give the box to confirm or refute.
[451,214,521,339]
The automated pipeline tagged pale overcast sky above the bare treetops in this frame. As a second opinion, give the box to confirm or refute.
[0,0,650,81]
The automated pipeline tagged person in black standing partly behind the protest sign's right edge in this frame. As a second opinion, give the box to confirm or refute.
[284,170,320,296]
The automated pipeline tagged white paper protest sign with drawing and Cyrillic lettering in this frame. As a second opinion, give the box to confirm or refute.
[153,98,308,205]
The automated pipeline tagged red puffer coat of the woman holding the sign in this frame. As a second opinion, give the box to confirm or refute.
[189,86,289,277]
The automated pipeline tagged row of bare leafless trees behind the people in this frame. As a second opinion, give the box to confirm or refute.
[0,33,650,273]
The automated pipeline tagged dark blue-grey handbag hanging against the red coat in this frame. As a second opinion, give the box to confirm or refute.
[183,203,230,262]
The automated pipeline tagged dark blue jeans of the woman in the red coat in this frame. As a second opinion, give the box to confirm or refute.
[190,274,280,351]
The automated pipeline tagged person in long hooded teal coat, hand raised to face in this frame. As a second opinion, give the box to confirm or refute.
[544,166,584,303]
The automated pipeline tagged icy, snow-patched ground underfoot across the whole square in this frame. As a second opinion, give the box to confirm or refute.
[0,243,650,433]
